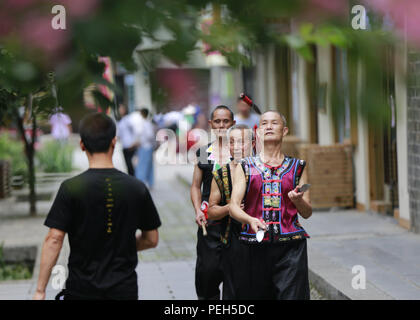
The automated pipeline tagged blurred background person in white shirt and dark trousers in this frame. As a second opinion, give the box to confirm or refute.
[117,104,137,176]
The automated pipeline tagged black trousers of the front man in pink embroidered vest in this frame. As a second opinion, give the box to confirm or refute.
[236,239,310,300]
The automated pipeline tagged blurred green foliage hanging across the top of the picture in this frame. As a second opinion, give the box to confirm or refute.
[0,0,406,125]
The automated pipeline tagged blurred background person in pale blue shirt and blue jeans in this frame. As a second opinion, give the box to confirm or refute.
[136,108,156,189]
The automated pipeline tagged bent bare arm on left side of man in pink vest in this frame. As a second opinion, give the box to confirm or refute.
[229,165,266,232]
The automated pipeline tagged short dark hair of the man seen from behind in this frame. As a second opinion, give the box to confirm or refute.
[79,112,117,153]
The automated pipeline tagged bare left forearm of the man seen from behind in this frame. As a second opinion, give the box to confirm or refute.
[33,228,66,300]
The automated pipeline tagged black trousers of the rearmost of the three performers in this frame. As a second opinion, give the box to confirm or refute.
[195,224,223,300]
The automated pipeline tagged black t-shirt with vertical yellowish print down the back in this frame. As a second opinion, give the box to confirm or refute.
[45,169,161,299]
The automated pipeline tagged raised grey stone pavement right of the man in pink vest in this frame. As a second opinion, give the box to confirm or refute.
[301,210,420,300]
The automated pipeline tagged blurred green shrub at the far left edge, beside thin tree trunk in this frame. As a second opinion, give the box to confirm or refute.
[0,133,27,177]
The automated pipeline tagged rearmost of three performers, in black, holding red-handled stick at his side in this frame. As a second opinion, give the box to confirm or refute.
[190,106,235,300]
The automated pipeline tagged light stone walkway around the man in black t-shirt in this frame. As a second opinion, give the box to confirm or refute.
[0,143,322,300]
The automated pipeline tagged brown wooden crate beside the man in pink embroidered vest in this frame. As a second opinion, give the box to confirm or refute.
[298,144,354,208]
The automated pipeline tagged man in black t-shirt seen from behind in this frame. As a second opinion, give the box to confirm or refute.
[34,113,161,300]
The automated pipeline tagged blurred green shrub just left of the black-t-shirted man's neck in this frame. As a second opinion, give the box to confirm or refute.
[36,140,74,173]
